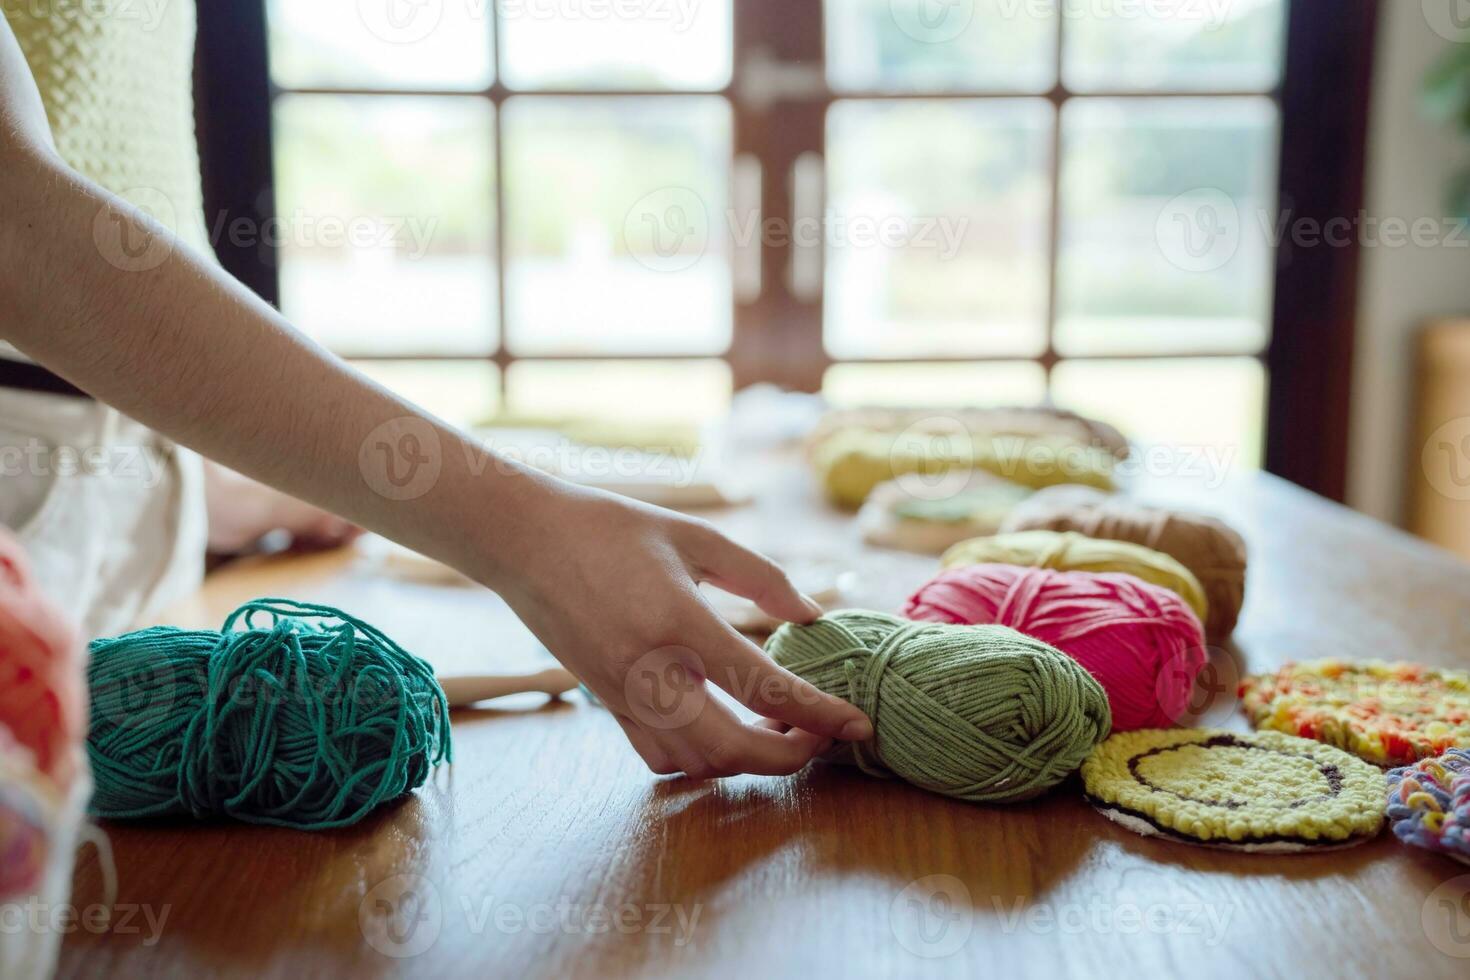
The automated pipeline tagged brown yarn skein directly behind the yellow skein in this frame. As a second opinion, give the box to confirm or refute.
[1001,486,1245,644]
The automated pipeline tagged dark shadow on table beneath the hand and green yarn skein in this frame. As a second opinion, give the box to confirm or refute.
[555,764,1092,964]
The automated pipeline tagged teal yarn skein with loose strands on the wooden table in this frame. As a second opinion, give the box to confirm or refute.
[87,598,453,830]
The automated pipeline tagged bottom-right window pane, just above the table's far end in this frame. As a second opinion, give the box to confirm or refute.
[1051,357,1266,476]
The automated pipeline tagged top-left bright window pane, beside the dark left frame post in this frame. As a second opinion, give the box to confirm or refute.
[266,0,494,90]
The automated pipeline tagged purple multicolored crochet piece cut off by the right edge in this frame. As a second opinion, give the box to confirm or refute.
[1388,749,1470,864]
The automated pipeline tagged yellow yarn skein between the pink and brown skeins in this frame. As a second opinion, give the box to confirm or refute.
[941,530,1210,623]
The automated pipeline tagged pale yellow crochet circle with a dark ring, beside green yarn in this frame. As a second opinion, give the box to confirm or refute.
[1082,729,1386,852]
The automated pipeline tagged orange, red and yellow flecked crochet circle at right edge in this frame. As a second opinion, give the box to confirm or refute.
[1241,660,1470,765]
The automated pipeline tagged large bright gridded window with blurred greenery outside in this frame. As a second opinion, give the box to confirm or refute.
[258,0,1286,463]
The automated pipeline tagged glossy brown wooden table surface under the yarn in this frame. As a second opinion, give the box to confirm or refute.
[59,460,1470,980]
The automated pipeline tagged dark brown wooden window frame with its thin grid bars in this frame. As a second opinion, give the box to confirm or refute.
[196,0,1377,500]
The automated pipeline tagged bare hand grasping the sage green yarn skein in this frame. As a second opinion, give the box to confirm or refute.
[491,486,873,779]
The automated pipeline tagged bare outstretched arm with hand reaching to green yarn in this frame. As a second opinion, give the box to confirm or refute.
[0,19,872,776]
